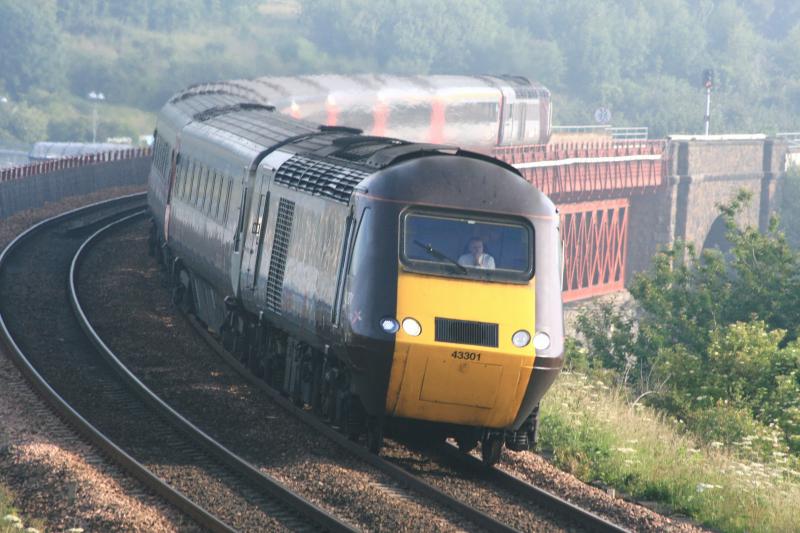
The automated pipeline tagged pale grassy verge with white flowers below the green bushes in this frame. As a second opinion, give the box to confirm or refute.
[540,373,800,531]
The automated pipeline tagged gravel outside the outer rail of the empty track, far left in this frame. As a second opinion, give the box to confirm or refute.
[0,187,193,532]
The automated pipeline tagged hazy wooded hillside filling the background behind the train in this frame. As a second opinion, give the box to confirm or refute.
[0,0,800,142]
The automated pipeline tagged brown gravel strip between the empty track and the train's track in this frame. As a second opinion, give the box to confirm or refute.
[79,217,494,531]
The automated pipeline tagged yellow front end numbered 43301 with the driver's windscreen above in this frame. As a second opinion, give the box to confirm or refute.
[386,207,536,429]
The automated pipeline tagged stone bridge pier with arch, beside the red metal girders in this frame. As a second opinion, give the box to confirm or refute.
[625,135,786,281]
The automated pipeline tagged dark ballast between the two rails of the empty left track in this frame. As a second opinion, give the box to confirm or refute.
[0,199,318,531]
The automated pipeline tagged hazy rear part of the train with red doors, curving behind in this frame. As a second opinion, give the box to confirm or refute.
[173,74,553,153]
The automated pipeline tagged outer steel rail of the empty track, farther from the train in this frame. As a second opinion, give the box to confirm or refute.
[0,193,235,533]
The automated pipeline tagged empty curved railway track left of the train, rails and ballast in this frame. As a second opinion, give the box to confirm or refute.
[0,194,354,532]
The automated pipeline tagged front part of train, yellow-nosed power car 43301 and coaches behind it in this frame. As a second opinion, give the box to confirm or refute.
[147,83,564,464]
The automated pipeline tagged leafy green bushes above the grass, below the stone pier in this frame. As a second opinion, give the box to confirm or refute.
[574,192,800,455]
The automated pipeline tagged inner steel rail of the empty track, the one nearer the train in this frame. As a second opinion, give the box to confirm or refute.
[69,212,358,533]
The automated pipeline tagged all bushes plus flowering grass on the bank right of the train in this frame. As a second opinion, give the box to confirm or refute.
[542,192,800,531]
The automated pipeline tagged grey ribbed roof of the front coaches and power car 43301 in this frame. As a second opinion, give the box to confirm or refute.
[162,83,519,202]
